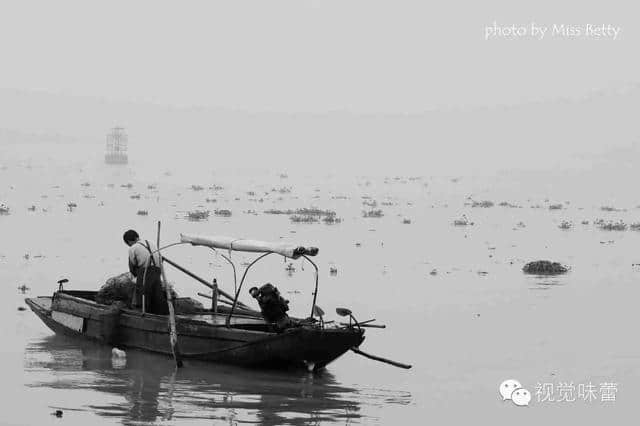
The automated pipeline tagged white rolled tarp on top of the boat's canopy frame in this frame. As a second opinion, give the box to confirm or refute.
[180,234,318,259]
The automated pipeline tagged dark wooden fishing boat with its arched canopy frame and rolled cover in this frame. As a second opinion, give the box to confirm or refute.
[26,235,364,370]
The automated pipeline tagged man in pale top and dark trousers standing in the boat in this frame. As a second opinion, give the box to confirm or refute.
[122,229,169,315]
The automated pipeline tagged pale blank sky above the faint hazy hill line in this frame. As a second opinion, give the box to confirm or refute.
[0,0,640,112]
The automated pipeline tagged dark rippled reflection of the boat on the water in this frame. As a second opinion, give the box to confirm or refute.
[25,336,363,424]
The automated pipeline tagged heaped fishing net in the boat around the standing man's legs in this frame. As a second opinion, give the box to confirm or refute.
[95,272,205,314]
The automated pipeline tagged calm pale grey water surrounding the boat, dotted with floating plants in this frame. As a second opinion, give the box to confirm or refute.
[0,146,640,424]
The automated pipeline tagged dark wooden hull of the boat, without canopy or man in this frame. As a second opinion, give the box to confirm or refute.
[26,292,364,369]
